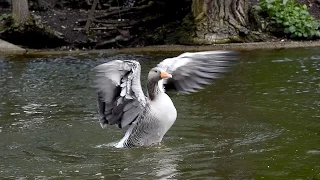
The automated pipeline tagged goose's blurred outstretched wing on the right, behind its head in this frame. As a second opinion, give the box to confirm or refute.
[158,51,236,93]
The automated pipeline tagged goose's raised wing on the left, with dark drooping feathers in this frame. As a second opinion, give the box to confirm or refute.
[93,60,146,128]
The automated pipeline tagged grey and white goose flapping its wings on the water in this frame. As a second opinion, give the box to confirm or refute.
[93,51,236,148]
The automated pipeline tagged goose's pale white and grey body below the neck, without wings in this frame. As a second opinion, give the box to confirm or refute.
[116,92,177,148]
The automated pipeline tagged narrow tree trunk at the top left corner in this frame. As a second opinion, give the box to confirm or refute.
[12,0,29,24]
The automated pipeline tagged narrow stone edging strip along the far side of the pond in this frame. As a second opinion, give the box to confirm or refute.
[0,40,320,56]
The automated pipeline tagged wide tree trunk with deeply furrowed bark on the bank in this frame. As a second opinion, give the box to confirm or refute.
[192,0,249,44]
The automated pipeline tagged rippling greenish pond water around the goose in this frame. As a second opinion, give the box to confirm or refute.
[0,48,320,179]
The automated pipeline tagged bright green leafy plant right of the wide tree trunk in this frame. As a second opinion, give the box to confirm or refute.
[255,0,320,39]
